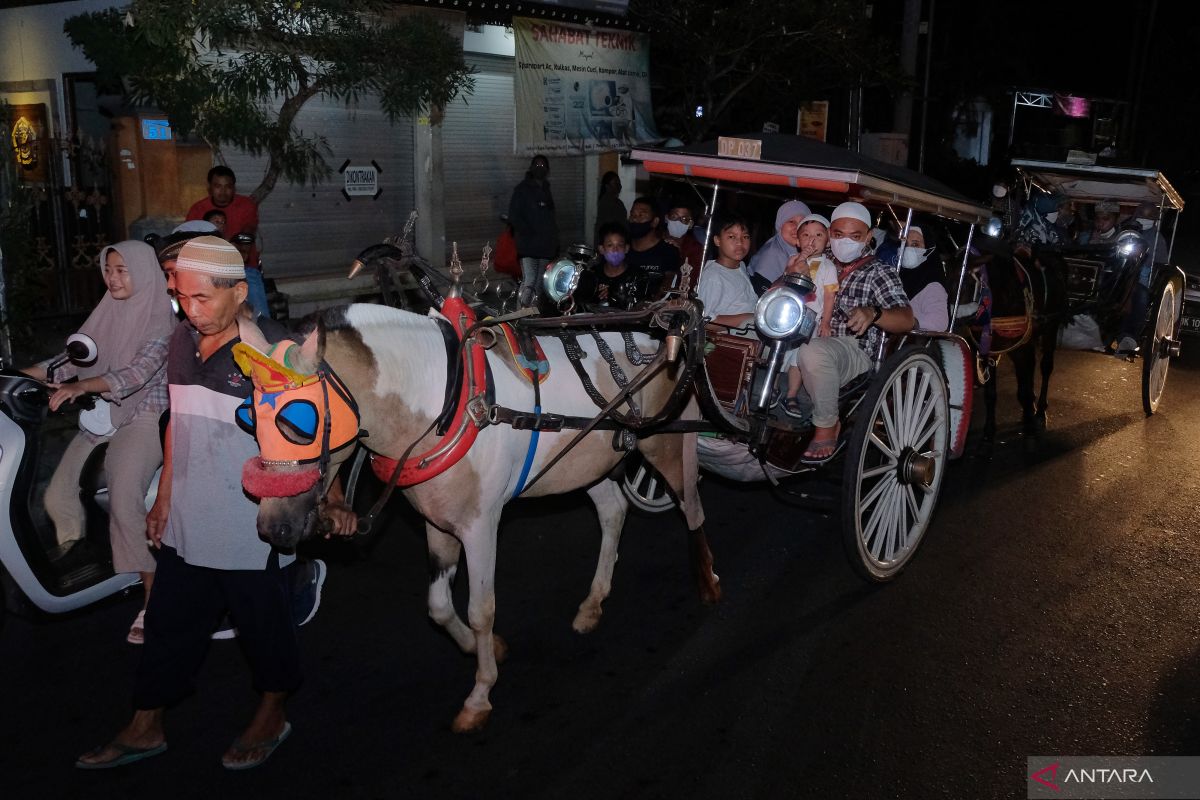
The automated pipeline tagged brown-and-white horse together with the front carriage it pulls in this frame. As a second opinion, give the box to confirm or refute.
[239,136,990,730]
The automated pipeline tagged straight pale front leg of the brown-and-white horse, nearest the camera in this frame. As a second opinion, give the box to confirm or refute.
[451,513,504,733]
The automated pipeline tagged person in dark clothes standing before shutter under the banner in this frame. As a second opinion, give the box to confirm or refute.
[509,155,558,307]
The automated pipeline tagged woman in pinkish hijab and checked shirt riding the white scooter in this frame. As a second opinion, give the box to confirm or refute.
[25,241,175,644]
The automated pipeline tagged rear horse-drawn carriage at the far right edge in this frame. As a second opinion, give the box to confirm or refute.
[998,158,1187,415]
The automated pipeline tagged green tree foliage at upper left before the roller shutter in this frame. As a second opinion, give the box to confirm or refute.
[64,0,474,201]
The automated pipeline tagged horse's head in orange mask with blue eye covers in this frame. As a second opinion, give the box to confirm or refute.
[235,323,359,548]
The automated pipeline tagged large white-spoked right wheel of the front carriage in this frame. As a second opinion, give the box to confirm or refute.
[841,347,950,583]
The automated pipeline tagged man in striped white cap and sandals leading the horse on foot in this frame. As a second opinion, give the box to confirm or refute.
[76,236,300,769]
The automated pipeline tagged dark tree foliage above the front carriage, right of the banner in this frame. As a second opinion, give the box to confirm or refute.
[629,0,902,142]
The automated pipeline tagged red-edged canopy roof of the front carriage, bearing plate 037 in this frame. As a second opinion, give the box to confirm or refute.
[630,133,991,223]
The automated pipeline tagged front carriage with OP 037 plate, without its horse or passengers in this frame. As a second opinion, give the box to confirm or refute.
[609,134,990,581]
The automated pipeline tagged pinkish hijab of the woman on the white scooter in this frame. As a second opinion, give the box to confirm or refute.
[78,240,176,428]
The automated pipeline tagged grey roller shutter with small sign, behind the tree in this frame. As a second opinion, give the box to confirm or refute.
[224,97,413,278]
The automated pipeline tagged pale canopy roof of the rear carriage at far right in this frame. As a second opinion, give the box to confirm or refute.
[1013,158,1183,211]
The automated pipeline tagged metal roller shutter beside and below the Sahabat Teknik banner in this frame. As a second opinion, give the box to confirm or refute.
[442,53,588,264]
